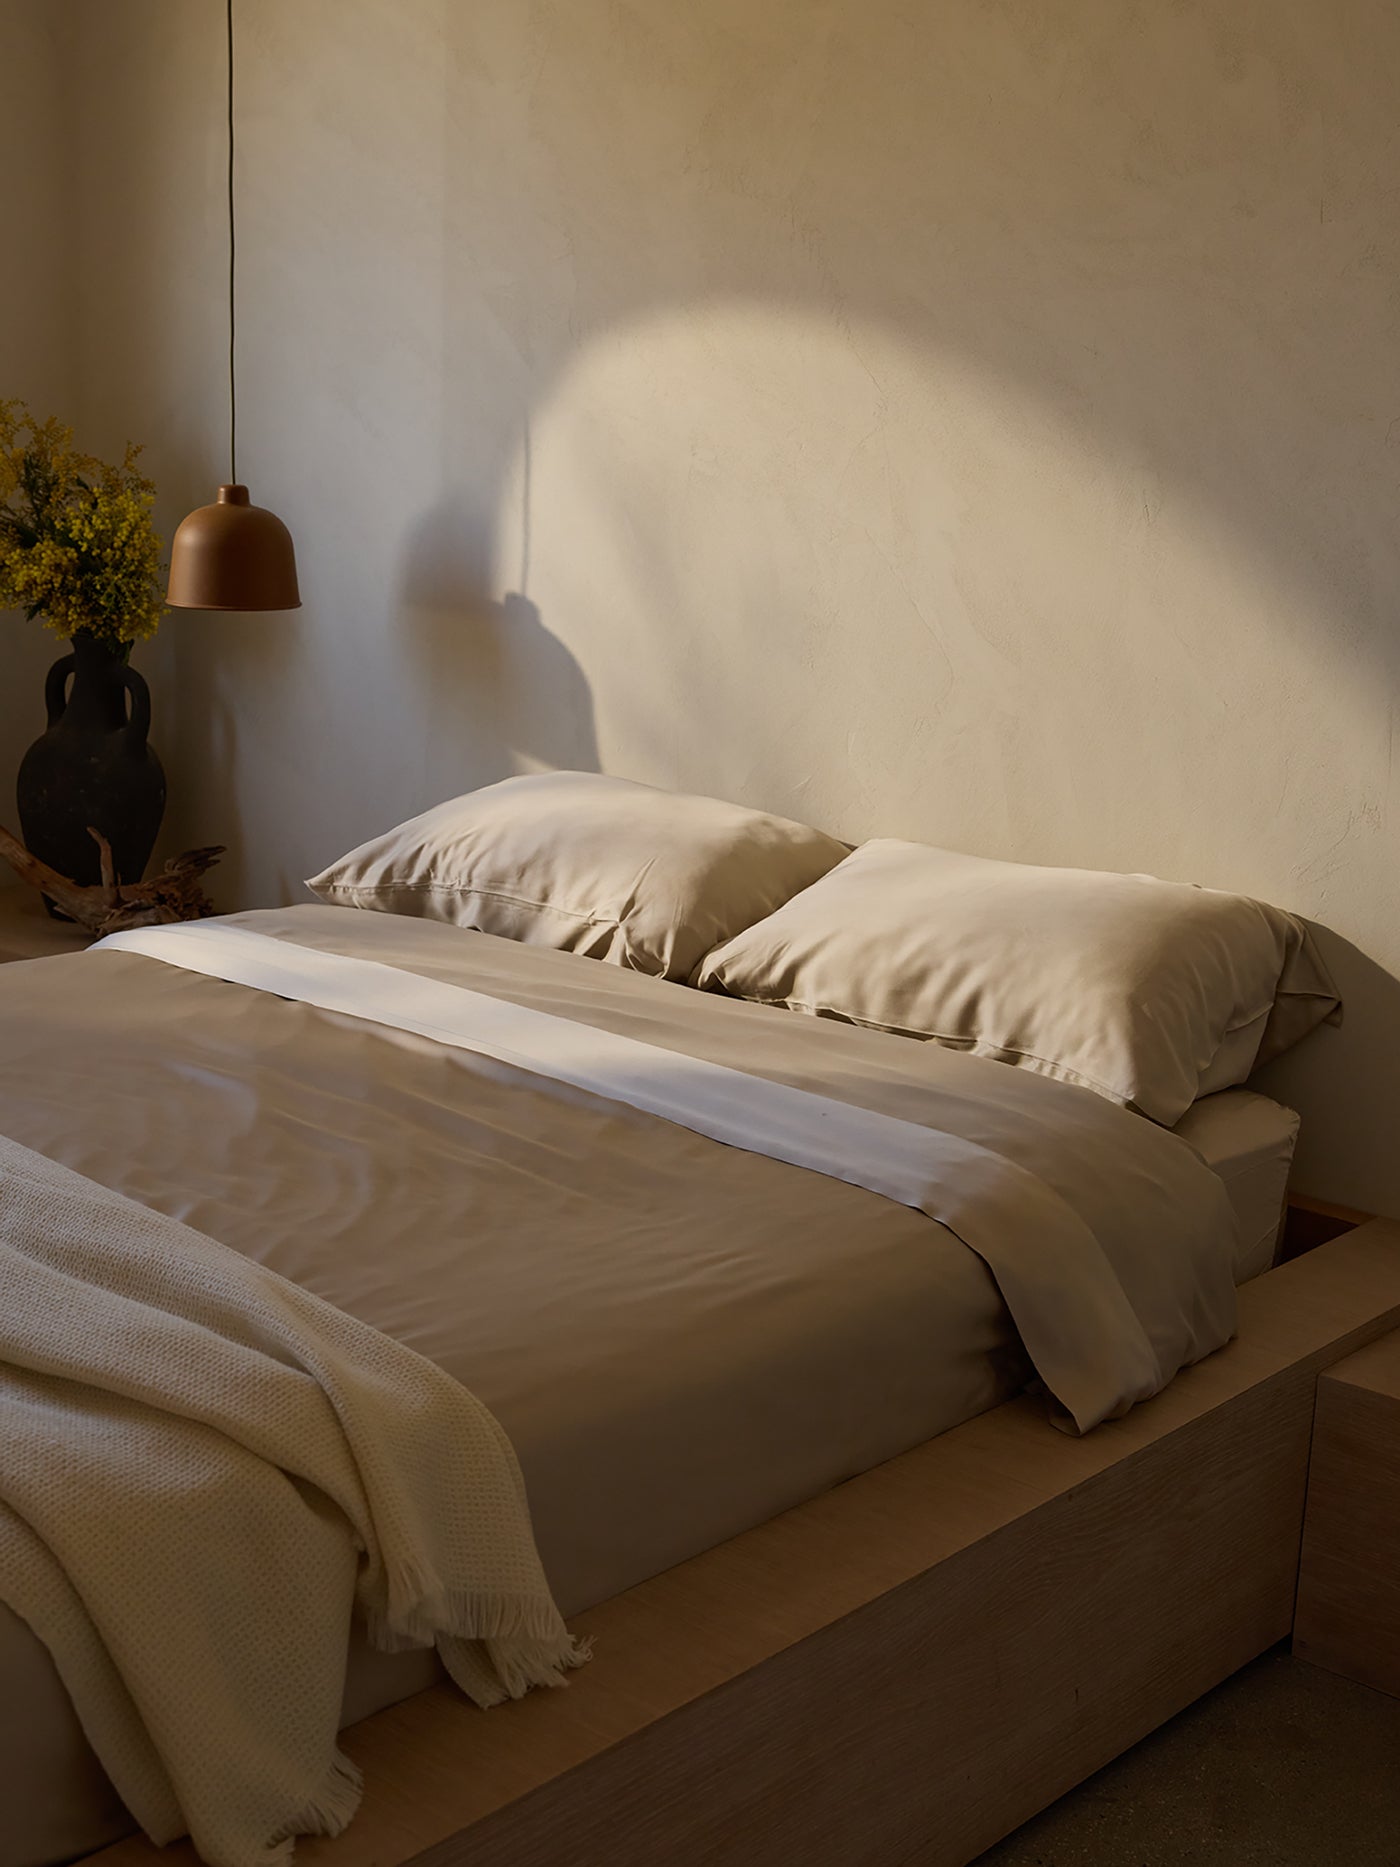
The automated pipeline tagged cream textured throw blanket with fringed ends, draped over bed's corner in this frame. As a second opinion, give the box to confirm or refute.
[0,1139,582,1867]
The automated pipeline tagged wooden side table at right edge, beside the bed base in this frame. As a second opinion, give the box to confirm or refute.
[1294,1329,1400,1697]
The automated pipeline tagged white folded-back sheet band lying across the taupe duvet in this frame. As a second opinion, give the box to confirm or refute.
[98,920,1234,1432]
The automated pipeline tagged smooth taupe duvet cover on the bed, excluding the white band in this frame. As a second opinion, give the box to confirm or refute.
[0,907,1232,1867]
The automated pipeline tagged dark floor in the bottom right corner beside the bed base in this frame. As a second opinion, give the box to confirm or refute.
[974,1649,1400,1867]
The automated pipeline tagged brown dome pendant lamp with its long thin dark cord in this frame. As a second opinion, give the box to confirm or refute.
[166,0,301,609]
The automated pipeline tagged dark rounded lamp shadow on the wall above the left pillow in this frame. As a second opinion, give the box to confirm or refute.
[398,506,599,787]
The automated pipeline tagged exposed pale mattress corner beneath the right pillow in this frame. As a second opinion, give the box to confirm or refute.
[1176,1088,1297,1284]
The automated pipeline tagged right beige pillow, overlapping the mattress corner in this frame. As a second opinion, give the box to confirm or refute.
[694,840,1340,1126]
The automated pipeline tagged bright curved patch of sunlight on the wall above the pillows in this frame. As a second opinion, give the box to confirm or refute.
[495,302,1389,905]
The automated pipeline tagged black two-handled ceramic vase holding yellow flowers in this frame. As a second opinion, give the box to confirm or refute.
[17,629,166,913]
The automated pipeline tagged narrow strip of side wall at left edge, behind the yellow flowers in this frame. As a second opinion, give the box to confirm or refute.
[0,0,77,817]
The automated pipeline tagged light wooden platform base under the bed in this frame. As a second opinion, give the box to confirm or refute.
[90,1221,1400,1867]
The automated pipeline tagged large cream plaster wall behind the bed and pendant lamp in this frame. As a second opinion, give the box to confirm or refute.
[32,0,1400,1212]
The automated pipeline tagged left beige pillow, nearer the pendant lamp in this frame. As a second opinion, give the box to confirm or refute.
[306,771,847,978]
